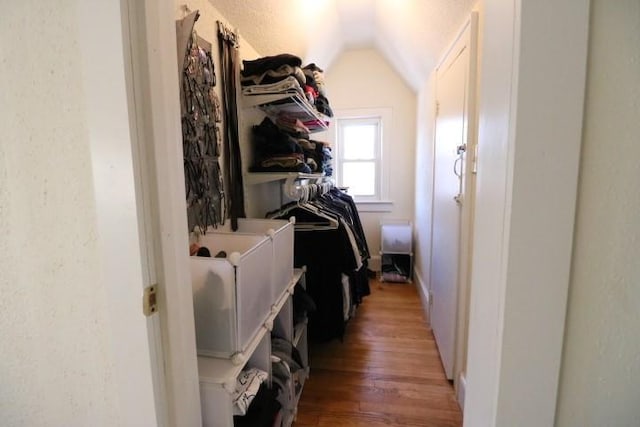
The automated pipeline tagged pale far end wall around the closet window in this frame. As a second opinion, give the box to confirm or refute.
[318,49,416,255]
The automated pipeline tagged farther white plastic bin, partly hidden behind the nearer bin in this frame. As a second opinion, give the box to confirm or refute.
[212,218,294,302]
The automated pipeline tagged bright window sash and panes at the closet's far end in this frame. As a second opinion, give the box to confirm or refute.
[337,117,382,201]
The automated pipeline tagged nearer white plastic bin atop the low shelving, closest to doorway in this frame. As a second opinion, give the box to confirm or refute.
[190,233,275,358]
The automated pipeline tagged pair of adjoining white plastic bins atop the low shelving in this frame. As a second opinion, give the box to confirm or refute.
[191,219,293,358]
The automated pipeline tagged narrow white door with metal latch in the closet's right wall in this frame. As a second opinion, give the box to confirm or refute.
[429,14,477,380]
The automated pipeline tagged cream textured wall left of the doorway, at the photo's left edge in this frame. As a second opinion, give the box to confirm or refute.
[0,1,120,426]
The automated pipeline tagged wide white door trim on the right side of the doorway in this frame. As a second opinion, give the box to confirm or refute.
[464,0,589,427]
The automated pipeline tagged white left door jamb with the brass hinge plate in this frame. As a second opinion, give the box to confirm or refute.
[121,0,202,427]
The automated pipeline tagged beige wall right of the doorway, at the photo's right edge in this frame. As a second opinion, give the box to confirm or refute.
[556,0,640,427]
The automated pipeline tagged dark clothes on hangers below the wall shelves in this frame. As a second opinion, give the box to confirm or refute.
[267,188,370,341]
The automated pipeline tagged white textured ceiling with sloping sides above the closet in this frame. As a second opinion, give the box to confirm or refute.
[209,0,474,90]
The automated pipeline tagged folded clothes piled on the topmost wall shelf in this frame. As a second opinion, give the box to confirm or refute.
[240,53,333,121]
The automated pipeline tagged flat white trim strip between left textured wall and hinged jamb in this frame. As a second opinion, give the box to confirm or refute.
[77,2,162,426]
